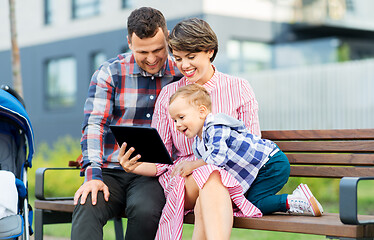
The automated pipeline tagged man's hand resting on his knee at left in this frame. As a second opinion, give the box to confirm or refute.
[74,180,110,205]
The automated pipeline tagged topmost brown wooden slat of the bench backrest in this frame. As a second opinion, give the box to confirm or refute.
[261,129,374,140]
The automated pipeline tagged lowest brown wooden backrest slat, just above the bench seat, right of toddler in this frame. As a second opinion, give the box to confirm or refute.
[290,166,374,178]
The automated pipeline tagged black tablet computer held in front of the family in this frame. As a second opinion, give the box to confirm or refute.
[110,125,173,164]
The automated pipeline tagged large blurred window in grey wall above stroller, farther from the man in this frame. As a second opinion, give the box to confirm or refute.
[45,57,77,110]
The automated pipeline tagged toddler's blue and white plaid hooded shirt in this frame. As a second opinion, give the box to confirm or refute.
[193,113,278,192]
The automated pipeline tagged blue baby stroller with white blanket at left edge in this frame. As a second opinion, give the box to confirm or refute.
[0,85,34,239]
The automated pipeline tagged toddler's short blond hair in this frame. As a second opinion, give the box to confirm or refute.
[169,83,212,111]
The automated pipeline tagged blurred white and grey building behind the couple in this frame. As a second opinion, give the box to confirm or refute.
[0,0,374,143]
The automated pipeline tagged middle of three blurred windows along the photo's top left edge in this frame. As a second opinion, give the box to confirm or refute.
[72,0,100,18]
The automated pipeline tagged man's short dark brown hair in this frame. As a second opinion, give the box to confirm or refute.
[127,7,168,42]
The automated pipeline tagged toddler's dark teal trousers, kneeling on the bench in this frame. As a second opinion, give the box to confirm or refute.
[246,151,290,215]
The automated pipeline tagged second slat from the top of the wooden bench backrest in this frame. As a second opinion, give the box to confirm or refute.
[276,140,374,153]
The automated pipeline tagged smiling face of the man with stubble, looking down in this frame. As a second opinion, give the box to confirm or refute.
[128,28,168,74]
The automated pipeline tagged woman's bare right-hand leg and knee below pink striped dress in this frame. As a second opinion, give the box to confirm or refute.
[199,171,234,239]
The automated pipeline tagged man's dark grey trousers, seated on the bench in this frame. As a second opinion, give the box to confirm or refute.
[71,169,165,240]
